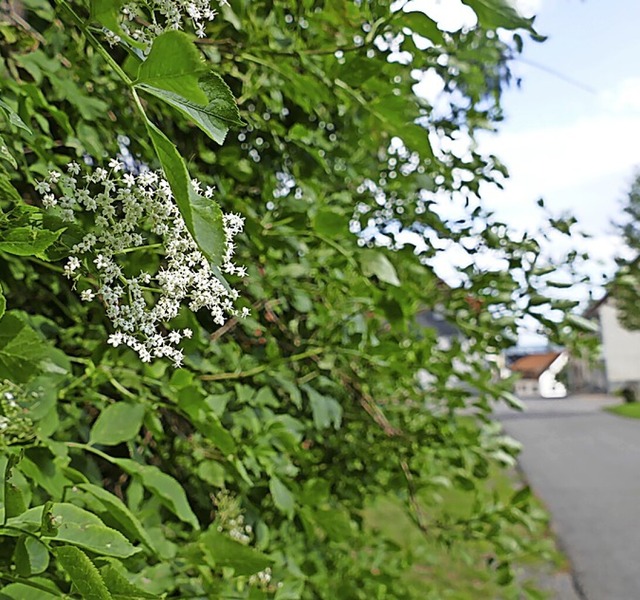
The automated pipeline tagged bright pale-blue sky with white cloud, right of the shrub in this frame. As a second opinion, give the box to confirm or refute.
[404,0,640,342]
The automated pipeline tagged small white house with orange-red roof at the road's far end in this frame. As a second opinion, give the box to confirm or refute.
[510,351,568,398]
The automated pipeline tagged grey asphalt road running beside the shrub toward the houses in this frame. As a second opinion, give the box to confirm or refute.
[497,396,640,600]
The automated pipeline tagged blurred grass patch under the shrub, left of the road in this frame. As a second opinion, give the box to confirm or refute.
[365,471,567,600]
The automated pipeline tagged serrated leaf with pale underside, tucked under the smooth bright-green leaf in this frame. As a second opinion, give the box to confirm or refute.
[139,73,243,144]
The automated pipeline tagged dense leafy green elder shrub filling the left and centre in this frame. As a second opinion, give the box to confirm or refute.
[0,0,580,600]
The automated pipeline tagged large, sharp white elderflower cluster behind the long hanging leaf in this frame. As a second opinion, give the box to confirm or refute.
[36,159,249,366]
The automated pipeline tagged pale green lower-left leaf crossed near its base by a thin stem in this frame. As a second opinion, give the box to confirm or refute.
[7,502,140,558]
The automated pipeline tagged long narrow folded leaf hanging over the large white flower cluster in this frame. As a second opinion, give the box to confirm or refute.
[147,121,226,265]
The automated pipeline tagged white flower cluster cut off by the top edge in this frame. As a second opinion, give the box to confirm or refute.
[114,0,228,46]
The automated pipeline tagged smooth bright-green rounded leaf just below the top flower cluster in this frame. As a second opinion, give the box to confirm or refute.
[135,31,209,105]
